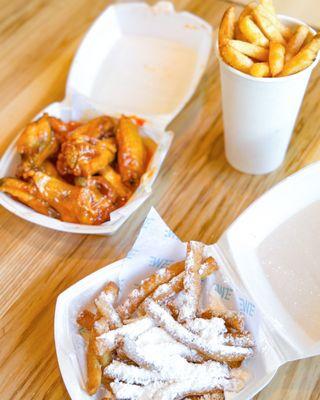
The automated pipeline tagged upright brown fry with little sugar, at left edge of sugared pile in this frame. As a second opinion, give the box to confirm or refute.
[86,330,102,395]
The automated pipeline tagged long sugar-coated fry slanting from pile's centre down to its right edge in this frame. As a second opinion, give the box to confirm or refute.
[145,299,253,362]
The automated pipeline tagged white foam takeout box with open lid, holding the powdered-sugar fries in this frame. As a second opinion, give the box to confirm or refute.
[55,162,320,400]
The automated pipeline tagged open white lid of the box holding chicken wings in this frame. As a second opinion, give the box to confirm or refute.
[67,2,212,130]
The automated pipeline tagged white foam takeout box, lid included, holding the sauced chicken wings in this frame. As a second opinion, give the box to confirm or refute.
[0,2,212,234]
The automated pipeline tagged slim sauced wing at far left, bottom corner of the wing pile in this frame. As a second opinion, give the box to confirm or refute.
[0,178,59,218]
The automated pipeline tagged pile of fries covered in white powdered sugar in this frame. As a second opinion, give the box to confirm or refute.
[77,242,254,400]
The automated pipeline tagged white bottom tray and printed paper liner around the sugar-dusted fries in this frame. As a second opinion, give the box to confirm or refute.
[55,209,281,400]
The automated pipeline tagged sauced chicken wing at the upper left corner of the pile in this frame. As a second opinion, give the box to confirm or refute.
[17,114,59,167]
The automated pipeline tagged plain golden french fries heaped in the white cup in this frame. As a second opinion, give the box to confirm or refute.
[219,0,320,78]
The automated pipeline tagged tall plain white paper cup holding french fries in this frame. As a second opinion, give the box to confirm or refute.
[216,16,320,175]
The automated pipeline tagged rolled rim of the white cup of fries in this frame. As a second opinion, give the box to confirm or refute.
[215,14,320,84]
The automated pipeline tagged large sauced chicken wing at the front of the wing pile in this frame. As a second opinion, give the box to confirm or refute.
[32,172,115,225]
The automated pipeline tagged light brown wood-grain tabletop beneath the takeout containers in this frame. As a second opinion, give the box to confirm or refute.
[0,0,320,400]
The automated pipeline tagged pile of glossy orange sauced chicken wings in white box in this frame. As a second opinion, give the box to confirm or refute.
[0,114,155,225]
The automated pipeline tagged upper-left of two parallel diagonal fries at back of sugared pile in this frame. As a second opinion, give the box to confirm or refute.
[117,261,184,319]
